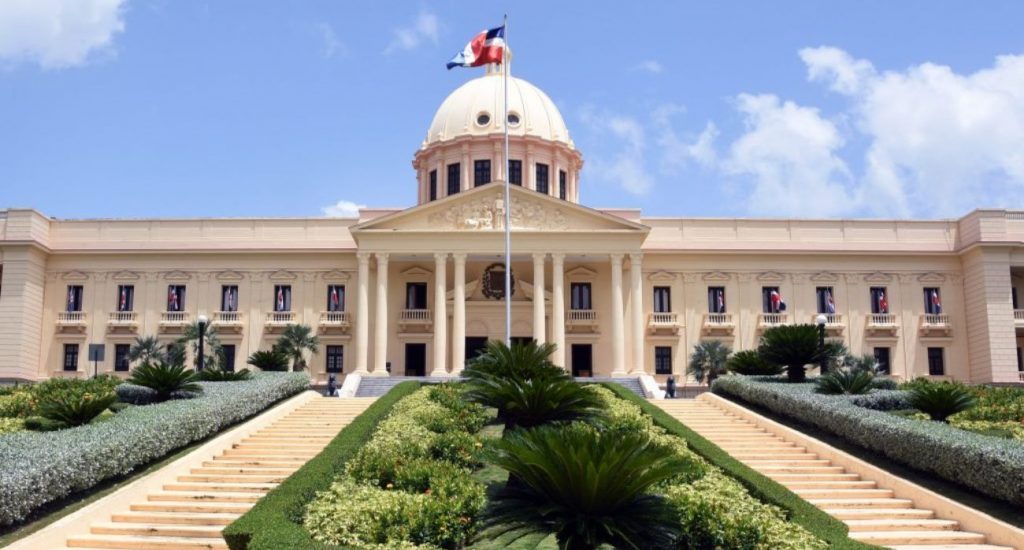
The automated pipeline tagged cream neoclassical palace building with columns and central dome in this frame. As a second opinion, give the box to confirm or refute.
[0,69,1024,382]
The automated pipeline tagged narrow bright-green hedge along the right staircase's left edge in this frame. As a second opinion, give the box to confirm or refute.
[605,384,876,549]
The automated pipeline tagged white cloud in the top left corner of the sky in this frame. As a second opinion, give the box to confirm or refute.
[0,0,126,69]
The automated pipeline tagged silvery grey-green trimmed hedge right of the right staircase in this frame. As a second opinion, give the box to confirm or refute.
[712,376,1024,504]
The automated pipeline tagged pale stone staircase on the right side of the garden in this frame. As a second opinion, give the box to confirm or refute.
[651,399,1013,550]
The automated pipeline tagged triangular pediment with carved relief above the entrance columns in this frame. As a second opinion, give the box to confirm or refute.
[350,183,649,235]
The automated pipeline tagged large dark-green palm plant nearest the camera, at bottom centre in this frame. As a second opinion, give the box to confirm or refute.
[484,424,688,550]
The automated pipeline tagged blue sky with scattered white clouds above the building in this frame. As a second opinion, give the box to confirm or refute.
[0,0,1024,217]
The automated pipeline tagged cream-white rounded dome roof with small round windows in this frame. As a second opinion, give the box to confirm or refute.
[424,68,573,147]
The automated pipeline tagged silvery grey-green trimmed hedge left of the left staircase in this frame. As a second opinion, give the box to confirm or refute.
[0,373,309,525]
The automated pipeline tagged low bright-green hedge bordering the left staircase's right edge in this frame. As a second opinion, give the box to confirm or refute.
[223,382,421,550]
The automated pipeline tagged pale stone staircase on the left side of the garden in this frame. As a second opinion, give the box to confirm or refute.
[57,396,374,550]
